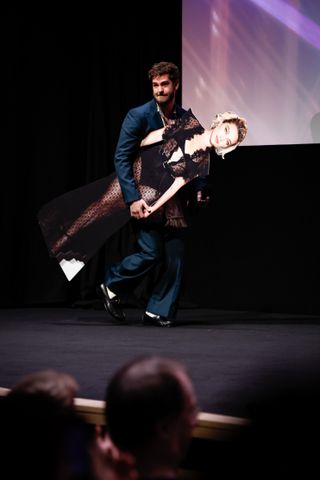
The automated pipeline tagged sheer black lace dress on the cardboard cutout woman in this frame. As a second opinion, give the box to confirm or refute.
[38,110,210,280]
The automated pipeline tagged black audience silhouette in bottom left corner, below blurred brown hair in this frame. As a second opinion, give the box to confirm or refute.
[0,390,94,480]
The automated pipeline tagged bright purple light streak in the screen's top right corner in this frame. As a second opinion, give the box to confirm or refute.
[250,0,320,49]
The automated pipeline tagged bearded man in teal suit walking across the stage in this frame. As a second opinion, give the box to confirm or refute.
[99,62,208,327]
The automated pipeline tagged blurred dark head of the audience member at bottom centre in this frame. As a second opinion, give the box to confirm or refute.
[105,356,198,479]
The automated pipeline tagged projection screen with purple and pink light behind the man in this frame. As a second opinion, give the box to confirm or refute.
[182,0,320,145]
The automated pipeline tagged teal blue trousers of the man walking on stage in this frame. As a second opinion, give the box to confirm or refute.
[104,221,186,319]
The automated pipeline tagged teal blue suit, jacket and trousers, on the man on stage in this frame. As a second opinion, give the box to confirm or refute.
[105,100,186,319]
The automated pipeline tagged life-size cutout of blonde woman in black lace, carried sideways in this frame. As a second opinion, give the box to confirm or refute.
[38,110,247,280]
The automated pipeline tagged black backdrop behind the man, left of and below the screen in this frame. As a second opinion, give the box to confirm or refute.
[0,5,320,313]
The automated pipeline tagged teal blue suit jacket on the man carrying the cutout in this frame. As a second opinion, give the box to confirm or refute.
[114,99,186,204]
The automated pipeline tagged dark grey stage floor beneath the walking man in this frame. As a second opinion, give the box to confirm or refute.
[0,304,320,417]
